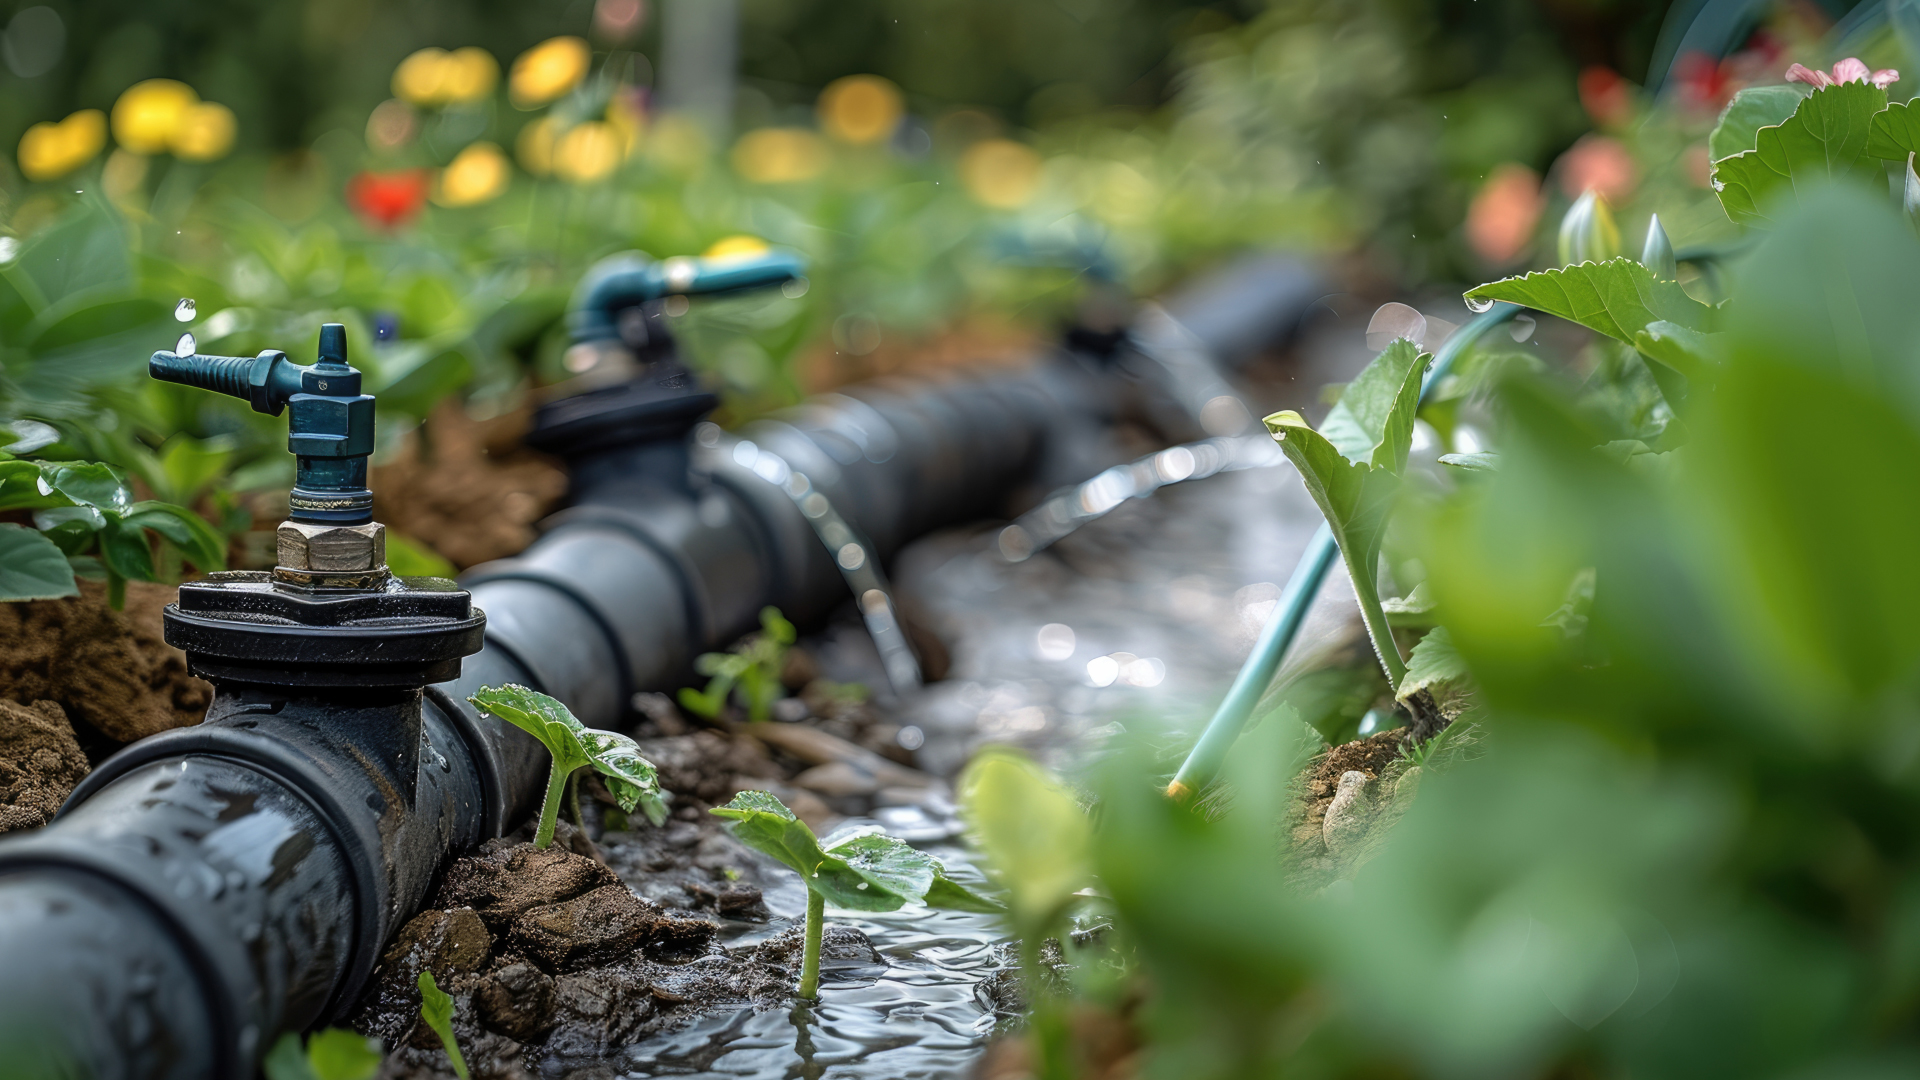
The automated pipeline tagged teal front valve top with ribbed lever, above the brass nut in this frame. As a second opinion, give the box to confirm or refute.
[146,323,374,525]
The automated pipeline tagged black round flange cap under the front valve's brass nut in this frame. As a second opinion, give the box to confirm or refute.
[163,571,486,688]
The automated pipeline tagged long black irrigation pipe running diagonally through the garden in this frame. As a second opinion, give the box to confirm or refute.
[0,247,1317,1080]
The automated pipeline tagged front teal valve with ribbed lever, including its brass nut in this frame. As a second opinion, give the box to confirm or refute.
[148,323,388,588]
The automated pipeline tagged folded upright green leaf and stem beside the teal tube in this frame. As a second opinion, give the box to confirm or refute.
[1267,338,1430,686]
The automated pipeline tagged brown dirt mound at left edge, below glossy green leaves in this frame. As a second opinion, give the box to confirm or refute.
[0,580,213,749]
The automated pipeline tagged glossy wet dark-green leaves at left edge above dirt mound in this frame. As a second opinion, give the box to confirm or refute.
[0,448,227,607]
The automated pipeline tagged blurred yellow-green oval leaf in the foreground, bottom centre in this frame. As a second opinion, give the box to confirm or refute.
[960,749,1092,936]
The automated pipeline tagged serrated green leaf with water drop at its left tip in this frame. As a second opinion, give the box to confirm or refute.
[1467,258,1715,344]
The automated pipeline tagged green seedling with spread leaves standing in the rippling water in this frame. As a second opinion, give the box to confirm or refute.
[712,792,1002,997]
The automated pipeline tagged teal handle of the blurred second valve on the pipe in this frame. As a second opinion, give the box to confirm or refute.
[566,248,806,342]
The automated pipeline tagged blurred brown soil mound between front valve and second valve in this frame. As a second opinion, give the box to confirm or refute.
[369,398,566,569]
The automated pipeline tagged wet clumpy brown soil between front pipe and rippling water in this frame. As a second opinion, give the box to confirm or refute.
[353,822,885,1080]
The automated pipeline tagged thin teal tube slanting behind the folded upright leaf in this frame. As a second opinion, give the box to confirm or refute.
[1167,304,1524,799]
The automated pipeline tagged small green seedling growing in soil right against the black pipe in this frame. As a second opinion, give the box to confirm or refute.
[468,682,666,847]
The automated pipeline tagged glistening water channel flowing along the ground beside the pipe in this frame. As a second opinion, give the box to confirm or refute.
[583,449,1352,1080]
